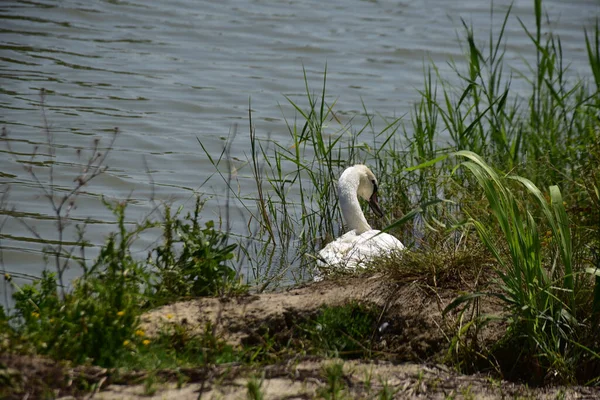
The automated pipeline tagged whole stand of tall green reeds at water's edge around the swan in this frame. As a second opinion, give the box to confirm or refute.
[203,0,600,296]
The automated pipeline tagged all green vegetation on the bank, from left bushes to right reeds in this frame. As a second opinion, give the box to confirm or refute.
[0,1,600,397]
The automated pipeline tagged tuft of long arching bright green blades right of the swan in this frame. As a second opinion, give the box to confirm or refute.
[438,151,596,379]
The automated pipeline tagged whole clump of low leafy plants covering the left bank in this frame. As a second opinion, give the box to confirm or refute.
[0,152,241,367]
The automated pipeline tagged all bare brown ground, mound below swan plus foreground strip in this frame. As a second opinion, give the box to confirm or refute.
[0,275,600,400]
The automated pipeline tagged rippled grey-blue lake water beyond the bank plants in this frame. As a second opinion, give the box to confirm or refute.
[0,0,600,291]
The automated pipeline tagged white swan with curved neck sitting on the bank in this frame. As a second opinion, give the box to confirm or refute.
[315,164,404,280]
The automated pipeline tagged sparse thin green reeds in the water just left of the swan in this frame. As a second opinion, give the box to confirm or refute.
[205,70,404,289]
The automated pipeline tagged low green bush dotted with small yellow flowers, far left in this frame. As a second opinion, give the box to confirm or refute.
[12,203,152,366]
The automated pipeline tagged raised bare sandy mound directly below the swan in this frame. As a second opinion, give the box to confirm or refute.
[143,275,455,361]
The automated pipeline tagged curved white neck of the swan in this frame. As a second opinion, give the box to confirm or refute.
[338,169,371,235]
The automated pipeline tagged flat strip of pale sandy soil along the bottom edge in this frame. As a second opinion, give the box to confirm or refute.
[96,360,600,400]
